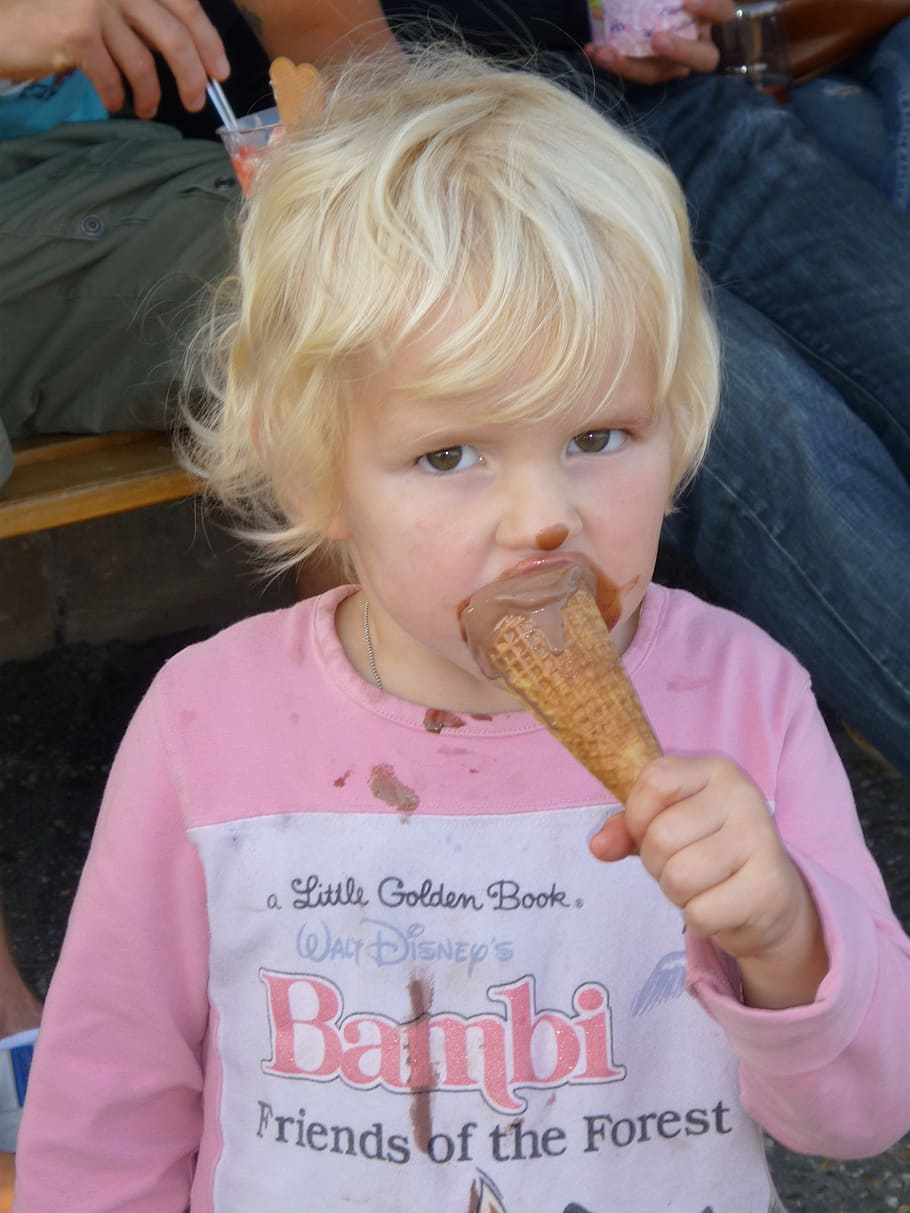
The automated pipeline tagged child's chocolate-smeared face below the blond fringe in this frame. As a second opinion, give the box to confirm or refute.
[329,337,671,712]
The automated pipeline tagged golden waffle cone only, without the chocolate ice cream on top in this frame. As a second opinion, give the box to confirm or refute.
[487,586,660,804]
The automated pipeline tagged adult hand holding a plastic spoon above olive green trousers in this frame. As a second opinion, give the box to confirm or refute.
[0,0,231,118]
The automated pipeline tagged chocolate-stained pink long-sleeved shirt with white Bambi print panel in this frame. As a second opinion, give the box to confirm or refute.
[16,587,910,1213]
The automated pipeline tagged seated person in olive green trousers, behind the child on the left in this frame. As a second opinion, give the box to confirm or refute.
[0,0,392,484]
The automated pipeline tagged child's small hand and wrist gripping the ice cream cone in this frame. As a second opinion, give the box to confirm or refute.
[591,756,827,1008]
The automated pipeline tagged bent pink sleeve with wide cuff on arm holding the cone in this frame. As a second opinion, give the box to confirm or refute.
[689,684,910,1157]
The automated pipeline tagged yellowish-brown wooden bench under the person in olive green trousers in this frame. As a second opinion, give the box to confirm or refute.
[0,431,200,540]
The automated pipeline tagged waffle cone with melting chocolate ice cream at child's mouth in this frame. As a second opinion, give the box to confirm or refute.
[462,564,661,803]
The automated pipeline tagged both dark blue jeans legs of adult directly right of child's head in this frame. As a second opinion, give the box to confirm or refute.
[613,76,910,775]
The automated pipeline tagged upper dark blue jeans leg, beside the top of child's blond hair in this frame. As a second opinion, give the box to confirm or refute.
[633,76,910,470]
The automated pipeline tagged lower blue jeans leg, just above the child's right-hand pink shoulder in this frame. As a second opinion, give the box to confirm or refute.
[664,290,910,776]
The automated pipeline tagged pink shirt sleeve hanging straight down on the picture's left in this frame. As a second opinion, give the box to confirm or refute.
[15,687,207,1213]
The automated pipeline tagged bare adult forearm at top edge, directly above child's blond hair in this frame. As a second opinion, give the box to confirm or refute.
[238,0,399,64]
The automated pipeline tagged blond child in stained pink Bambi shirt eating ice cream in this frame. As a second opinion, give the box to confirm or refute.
[17,47,910,1213]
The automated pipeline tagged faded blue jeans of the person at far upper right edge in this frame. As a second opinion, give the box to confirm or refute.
[791,18,910,212]
